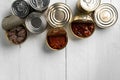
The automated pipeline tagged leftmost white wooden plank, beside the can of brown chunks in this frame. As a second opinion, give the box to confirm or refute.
[0,0,19,80]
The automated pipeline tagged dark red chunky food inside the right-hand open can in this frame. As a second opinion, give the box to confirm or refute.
[71,20,95,38]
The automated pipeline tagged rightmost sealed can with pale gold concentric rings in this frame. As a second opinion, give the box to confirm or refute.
[94,3,118,28]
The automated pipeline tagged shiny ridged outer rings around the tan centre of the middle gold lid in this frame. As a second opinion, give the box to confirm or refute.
[46,2,72,28]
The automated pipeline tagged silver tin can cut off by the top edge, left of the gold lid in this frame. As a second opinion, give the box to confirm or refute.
[29,0,50,12]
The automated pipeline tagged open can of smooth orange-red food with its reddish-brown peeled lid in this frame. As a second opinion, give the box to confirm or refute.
[47,27,68,50]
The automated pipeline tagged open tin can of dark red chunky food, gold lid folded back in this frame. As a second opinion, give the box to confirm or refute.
[70,13,95,39]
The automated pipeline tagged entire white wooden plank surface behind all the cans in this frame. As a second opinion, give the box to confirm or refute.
[0,0,120,80]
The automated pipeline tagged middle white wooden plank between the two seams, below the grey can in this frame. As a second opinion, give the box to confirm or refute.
[20,0,65,80]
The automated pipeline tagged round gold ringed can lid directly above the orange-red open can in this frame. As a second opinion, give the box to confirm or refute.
[46,3,72,27]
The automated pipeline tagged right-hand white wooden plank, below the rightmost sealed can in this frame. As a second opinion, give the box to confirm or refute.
[67,0,120,80]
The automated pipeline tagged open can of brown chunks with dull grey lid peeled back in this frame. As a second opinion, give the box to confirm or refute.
[2,15,27,44]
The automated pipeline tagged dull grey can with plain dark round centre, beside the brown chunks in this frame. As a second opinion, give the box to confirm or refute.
[25,12,47,33]
